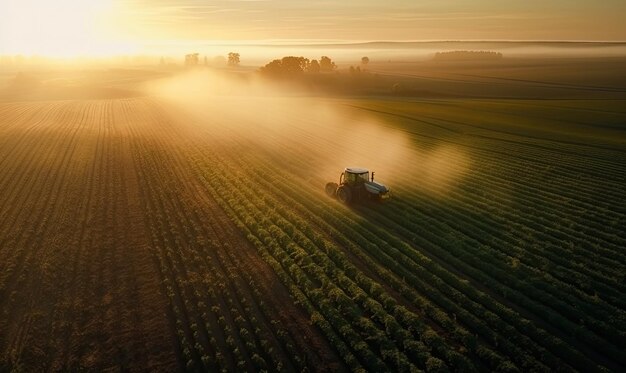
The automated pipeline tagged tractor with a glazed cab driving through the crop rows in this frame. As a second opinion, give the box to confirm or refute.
[326,167,391,204]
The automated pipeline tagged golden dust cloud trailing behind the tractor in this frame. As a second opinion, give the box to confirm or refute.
[146,70,470,194]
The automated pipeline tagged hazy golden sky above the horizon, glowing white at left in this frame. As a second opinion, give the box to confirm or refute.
[0,0,626,56]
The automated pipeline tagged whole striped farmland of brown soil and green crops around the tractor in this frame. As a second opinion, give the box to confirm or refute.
[0,58,626,372]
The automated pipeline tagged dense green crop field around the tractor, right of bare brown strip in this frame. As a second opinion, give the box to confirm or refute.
[190,94,626,371]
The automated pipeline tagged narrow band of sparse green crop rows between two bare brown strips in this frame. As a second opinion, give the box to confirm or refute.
[122,99,320,371]
